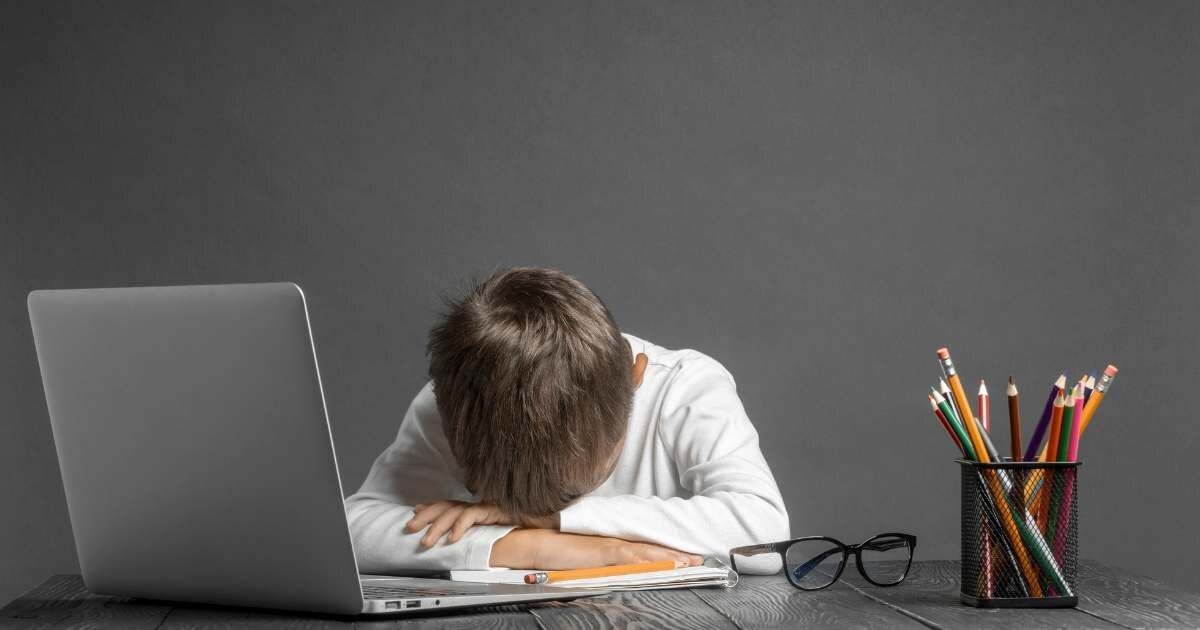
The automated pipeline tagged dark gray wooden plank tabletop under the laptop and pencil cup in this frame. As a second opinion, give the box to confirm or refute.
[0,562,1200,629]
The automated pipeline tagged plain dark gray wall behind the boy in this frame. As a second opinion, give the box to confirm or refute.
[0,1,1200,600]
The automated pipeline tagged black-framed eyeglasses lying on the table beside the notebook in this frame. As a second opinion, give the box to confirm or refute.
[730,533,917,590]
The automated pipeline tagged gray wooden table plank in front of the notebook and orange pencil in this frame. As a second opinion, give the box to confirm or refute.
[529,589,736,630]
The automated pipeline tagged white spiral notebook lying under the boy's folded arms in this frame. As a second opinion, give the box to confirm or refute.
[450,558,738,590]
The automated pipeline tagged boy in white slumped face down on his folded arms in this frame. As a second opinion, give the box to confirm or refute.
[346,268,788,574]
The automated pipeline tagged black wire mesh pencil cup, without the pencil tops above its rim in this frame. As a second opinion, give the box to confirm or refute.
[958,460,1080,608]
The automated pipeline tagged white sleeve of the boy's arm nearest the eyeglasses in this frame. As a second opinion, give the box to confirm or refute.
[559,355,790,572]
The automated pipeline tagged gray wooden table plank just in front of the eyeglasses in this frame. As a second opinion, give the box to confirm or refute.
[695,575,924,629]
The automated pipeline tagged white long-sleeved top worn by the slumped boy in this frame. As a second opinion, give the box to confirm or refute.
[346,335,790,574]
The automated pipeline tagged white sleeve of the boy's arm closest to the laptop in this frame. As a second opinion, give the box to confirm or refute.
[346,385,512,574]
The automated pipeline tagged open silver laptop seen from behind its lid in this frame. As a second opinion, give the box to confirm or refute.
[29,283,606,614]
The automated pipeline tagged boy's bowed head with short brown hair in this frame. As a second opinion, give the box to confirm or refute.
[428,268,634,517]
